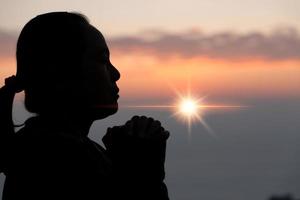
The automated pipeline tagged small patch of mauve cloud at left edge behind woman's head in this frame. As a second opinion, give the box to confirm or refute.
[0,30,17,58]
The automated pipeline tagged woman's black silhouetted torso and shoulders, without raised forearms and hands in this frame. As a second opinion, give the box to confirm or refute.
[2,118,112,200]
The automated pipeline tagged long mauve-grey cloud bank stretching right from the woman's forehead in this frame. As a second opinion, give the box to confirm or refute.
[109,28,300,60]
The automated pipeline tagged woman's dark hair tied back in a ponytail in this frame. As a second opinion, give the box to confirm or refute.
[0,12,90,132]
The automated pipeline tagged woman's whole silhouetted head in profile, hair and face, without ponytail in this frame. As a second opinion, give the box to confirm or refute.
[17,12,120,120]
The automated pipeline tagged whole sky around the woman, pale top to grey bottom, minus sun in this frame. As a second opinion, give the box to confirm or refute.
[0,0,300,200]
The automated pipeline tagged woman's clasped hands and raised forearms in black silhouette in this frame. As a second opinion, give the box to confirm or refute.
[103,117,169,200]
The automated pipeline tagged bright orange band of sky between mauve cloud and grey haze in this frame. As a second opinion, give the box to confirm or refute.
[0,46,300,100]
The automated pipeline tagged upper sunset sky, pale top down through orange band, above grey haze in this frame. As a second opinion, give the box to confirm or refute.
[0,0,300,103]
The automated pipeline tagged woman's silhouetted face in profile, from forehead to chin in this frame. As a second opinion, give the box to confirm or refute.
[82,26,120,118]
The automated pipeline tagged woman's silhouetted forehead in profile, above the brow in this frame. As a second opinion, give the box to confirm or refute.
[86,25,109,53]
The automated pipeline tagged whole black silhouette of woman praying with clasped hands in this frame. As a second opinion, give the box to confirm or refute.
[0,12,169,200]
